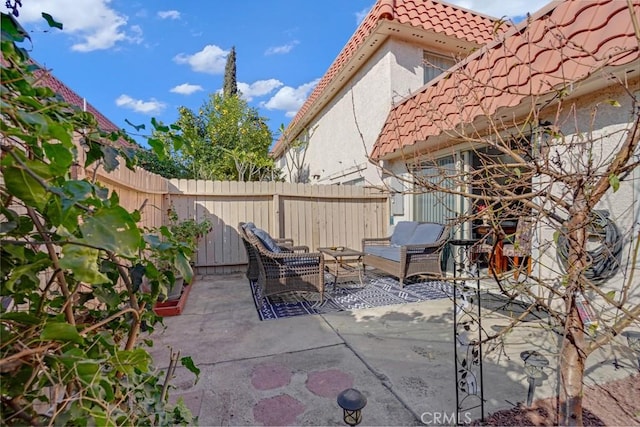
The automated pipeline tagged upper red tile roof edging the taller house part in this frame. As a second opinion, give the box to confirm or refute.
[273,0,495,157]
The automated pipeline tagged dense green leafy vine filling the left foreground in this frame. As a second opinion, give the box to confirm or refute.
[0,13,195,425]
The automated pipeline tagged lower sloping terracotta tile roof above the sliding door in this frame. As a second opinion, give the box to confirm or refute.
[371,0,640,159]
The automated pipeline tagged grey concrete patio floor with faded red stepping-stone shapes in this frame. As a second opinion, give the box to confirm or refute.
[146,274,637,426]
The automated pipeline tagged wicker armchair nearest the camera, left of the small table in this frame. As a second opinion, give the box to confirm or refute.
[245,228,324,301]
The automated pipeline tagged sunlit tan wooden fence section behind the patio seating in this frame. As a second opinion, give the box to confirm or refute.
[165,180,389,274]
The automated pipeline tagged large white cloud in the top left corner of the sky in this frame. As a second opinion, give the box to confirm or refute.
[13,0,140,52]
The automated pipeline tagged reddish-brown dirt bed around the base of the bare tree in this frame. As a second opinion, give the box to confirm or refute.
[476,374,640,426]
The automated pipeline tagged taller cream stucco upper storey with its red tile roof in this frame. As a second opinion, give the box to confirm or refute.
[271,0,498,185]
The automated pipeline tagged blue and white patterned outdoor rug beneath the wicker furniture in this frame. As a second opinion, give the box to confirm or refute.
[251,277,453,320]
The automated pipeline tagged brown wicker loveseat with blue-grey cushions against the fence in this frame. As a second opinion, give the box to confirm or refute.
[362,221,449,286]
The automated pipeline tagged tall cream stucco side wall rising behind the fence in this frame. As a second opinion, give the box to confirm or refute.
[279,40,432,185]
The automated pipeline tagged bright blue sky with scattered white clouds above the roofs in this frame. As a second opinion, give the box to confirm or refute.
[2,0,548,148]
